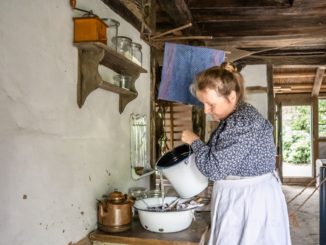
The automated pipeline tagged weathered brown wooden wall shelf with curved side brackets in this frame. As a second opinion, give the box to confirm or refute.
[74,42,147,113]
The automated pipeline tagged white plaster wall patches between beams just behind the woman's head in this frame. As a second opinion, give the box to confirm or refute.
[241,65,268,118]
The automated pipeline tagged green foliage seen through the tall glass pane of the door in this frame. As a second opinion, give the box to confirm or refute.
[282,106,311,164]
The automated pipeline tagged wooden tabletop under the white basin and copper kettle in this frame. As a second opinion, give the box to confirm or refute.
[89,212,210,245]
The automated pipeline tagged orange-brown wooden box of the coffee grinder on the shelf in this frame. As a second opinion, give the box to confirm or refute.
[74,16,108,44]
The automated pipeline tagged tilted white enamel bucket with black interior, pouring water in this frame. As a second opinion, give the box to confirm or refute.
[156,144,208,198]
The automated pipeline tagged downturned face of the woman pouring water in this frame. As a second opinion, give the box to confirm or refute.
[196,88,237,121]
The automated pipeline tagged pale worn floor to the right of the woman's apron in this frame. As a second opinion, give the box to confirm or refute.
[282,185,319,245]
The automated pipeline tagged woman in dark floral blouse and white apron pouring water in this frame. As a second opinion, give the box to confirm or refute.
[181,63,291,245]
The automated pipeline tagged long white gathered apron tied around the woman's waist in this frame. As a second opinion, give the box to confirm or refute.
[208,173,291,245]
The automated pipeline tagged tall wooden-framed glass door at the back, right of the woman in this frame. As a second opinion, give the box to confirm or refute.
[275,94,316,185]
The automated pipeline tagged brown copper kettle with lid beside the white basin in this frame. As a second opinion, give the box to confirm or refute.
[98,190,133,232]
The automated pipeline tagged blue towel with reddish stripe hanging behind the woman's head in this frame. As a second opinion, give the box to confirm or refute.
[158,43,225,106]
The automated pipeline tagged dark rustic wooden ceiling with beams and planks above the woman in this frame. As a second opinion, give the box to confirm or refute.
[102,0,326,95]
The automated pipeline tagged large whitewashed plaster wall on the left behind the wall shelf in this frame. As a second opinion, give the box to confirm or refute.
[0,0,150,245]
